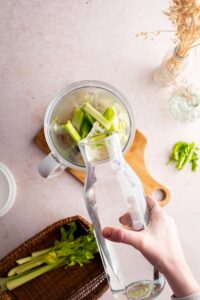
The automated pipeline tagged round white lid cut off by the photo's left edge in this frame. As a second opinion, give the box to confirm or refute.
[0,163,17,217]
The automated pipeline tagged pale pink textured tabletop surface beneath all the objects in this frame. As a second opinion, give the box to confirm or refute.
[0,0,200,300]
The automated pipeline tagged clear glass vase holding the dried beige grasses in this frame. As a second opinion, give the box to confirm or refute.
[154,47,189,86]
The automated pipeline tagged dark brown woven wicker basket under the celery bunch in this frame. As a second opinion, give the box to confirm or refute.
[0,216,108,300]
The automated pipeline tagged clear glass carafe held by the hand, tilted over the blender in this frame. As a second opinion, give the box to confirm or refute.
[79,133,165,300]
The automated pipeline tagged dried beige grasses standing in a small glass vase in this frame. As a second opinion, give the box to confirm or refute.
[136,0,200,85]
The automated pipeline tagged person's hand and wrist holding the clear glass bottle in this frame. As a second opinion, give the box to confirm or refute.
[102,197,199,297]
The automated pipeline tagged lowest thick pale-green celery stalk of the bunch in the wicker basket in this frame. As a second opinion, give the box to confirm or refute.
[6,264,61,291]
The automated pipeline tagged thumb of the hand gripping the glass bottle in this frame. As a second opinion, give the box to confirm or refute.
[102,227,142,250]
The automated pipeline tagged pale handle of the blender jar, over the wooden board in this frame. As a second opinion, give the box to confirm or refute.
[38,153,66,178]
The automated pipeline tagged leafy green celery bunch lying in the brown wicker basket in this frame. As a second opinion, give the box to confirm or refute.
[0,222,98,291]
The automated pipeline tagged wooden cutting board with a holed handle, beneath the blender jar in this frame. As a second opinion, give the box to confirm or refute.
[34,128,170,206]
